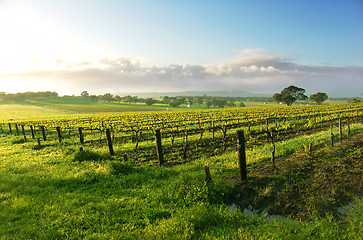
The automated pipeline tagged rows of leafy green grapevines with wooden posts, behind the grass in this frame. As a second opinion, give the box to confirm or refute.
[0,104,363,165]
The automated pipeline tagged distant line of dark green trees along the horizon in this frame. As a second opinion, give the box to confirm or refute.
[0,85,361,108]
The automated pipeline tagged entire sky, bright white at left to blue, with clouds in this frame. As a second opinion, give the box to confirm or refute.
[0,0,363,96]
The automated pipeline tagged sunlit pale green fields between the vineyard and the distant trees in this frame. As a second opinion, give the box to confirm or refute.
[0,97,345,121]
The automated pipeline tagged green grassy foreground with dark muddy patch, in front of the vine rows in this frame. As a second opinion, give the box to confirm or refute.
[0,124,363,239]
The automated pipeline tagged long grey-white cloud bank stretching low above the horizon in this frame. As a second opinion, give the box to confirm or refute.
[0,49,363,94]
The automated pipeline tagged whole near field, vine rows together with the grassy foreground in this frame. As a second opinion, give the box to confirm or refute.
[0,103,363,239]
